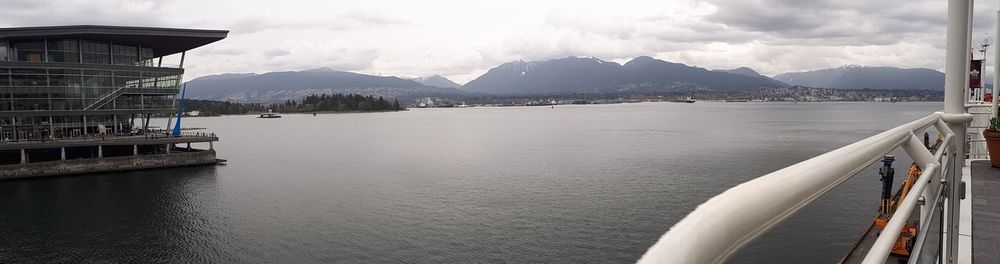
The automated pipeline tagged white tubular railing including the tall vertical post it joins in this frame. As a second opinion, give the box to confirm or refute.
[639,0,980,263]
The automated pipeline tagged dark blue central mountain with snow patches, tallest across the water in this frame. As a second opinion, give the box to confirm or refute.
[461,56,785,95]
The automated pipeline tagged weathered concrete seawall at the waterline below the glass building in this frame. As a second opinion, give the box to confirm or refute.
[0,150,219,180]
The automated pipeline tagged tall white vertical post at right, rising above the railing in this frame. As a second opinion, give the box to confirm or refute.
[943,0,972,263]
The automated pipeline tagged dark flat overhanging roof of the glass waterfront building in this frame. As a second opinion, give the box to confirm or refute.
[0,25,229,57]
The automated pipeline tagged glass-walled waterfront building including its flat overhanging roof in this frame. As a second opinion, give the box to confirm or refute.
[0,26,228,141]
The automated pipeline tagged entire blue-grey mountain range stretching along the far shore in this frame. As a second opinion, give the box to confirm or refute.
[187,56,944,103]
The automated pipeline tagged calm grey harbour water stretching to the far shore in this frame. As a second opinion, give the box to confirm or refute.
[0,102,941,263]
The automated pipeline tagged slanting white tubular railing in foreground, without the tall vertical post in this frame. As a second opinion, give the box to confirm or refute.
[639,112,972,263]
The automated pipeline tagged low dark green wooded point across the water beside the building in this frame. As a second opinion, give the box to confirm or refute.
[184,94,406,116]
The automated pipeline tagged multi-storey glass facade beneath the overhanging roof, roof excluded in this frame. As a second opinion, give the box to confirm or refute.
[0,38,183,141]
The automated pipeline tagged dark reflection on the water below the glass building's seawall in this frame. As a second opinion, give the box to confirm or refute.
[0,166,232,263]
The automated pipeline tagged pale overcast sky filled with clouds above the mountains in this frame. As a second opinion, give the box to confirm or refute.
[0,0,997,83]
